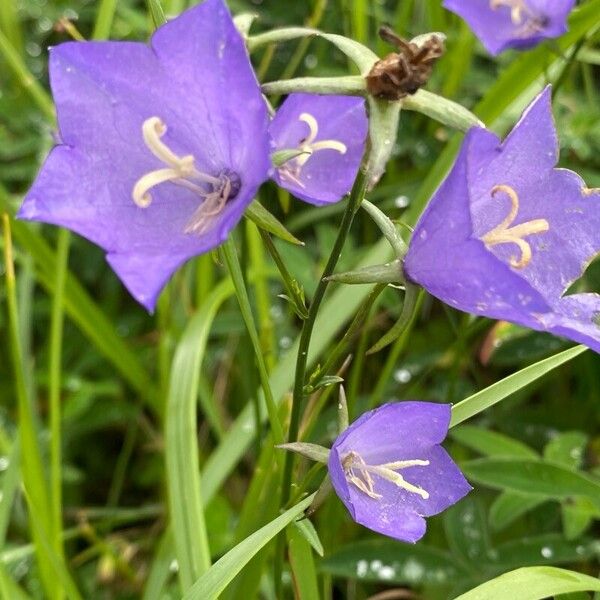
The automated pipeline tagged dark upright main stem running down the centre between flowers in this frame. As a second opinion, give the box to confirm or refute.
[274,159,368,598]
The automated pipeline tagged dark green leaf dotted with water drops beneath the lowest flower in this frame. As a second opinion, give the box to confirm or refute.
[320,539,465,585]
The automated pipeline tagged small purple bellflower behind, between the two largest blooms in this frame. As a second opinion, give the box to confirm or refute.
[269,94,368,206]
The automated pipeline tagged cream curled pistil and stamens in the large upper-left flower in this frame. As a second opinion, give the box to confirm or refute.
[131,117,242,234]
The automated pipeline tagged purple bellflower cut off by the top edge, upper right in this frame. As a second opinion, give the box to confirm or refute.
[444,0,575,55]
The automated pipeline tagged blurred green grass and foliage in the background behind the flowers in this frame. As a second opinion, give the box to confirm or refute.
[0,0,600,600]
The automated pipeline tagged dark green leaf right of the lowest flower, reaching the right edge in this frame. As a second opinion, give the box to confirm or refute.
[461,458,600,507]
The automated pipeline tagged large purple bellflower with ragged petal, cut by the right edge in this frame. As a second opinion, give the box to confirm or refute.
[404,88,600,352]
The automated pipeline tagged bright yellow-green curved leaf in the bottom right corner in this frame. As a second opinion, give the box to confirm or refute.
[455,567,600,600]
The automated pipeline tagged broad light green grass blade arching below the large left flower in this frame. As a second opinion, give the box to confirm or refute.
[165,281,233,592]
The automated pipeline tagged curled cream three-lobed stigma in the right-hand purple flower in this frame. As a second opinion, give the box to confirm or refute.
[481,185,550,269]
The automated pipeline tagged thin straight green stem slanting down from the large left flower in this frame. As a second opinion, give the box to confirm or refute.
[221,237,284,444]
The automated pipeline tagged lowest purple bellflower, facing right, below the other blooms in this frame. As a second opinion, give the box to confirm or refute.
[328,402,471,543]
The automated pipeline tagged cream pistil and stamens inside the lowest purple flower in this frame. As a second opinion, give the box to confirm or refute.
[342,450,429,500]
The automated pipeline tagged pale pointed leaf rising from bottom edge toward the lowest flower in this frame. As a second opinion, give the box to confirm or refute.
[183,494,314,600]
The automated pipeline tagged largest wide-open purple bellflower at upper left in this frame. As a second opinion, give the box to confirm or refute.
[19,0,270,310]
